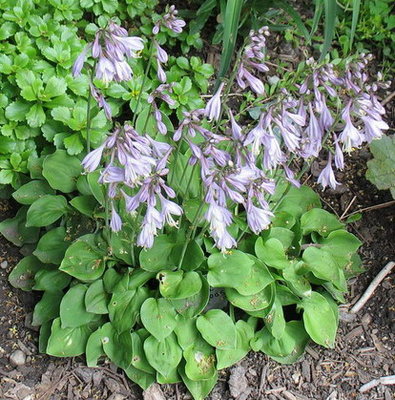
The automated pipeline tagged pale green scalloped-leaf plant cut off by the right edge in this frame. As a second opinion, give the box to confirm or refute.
[366,136,395,199]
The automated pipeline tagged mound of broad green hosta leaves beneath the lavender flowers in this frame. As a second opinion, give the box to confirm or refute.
[0,160,361,399]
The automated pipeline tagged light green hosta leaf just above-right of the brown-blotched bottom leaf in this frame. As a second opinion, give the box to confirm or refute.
[196,309,236,349]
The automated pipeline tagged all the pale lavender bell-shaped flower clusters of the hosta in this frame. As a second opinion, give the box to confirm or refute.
[73,18,388,251]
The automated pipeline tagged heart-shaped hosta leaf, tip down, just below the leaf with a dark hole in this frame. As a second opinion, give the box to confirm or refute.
[140,297,177,341]
